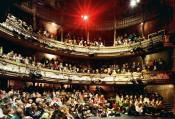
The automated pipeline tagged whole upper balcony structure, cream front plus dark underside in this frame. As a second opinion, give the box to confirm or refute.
[0,14,165,58]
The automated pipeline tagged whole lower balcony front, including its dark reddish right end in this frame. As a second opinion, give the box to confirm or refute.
[0,57,174,85]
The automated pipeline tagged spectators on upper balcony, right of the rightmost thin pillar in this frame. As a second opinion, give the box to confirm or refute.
[114,33,143,46]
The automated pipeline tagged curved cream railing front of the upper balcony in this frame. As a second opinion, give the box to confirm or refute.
[0,23,163,56]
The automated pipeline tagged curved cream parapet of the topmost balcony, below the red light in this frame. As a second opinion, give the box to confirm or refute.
[0,24,164,57]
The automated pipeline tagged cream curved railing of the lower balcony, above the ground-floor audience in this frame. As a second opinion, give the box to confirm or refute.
[0,57,170,84]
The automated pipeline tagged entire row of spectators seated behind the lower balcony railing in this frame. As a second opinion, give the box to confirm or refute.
[0,47,166,75]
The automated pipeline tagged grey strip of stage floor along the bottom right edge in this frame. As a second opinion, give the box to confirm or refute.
[88,115,174,119]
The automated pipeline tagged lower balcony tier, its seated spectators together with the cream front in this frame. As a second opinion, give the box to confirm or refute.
[0,47,169,84]
